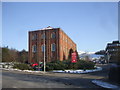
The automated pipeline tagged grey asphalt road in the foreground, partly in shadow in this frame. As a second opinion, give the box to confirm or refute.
[2,65,108,88]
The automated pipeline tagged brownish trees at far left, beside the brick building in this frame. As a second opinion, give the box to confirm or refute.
[2,46,28,63]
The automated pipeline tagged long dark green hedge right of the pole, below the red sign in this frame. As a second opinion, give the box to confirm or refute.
[42,60,95,71]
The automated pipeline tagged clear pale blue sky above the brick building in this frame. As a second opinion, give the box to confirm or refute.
[2,2,118,52]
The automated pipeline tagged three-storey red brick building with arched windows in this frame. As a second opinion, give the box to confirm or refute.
[29,27,76,63]
